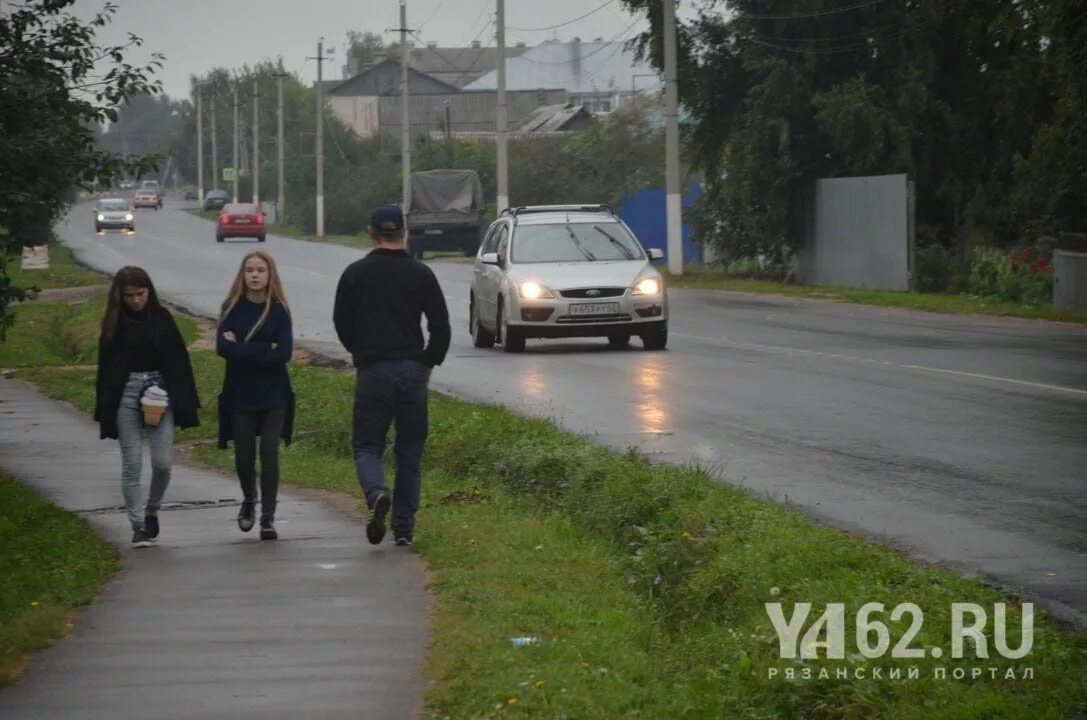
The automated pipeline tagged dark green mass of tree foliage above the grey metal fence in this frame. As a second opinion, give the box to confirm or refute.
[624,0,1087,267]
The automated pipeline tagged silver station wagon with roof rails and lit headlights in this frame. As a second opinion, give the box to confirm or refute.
[468,206,669,352]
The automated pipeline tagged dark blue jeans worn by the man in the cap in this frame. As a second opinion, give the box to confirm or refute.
[351,360,428,538]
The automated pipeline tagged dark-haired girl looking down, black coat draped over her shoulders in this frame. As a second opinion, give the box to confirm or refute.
[95,266,200,547]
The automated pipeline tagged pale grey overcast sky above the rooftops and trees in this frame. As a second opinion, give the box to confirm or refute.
[74,0,692,99]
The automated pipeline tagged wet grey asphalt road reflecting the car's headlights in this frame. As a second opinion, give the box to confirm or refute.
[58,203,1087,625]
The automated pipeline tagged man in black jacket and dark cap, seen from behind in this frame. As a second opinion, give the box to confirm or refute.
[333,206,450,546]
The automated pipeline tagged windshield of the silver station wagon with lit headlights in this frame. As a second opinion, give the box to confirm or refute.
[512,222,646,262]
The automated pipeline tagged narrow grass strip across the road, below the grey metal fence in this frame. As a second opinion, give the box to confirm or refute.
[662,268,1087,323]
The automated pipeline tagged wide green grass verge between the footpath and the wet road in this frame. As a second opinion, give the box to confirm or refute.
[8,295,1087,720]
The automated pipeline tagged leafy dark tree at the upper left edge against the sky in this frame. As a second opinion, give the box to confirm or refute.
[0,0,163,334]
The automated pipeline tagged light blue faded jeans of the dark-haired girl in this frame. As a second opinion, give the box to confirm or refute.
[117,372,174,530]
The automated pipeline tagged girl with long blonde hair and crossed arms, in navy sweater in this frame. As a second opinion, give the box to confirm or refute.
[215,250,295,539]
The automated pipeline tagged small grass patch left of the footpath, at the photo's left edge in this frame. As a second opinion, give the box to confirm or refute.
[0,472,120,686]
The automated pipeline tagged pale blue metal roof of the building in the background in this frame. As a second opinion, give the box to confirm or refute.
[465,41,658,92]
